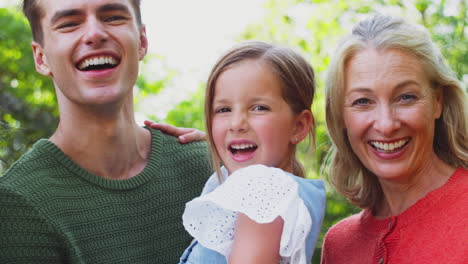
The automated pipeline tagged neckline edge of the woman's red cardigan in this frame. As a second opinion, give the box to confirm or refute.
[360,167,468,234]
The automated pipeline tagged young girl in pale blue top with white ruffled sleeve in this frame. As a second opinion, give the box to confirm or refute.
[148,41,325,263]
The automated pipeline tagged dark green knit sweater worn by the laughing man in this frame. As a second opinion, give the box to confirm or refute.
[0,129,212,264]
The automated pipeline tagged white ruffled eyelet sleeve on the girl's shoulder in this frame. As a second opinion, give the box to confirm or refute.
[182,165,312,264]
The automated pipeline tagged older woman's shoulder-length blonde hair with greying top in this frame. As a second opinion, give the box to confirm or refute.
[325,14,468,210]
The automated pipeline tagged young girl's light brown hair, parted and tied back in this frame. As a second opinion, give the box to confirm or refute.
[205,41,315,182]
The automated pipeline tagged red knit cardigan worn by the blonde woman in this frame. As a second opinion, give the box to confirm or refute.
[322,168,468,264]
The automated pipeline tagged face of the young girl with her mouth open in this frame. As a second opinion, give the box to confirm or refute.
[211,60,297,173]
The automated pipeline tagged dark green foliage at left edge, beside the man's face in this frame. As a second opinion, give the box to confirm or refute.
[0,8,58,174]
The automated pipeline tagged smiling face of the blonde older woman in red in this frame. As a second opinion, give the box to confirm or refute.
[343,48,442,180]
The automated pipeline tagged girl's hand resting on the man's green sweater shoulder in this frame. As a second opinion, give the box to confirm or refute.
[145,120,206,143]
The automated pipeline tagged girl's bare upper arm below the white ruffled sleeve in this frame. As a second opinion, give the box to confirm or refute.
[229,213,284,264]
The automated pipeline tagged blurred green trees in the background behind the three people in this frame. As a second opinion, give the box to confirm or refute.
[0,0,468,263]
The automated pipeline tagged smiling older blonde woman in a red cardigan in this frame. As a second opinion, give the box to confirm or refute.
[322,15,468,264]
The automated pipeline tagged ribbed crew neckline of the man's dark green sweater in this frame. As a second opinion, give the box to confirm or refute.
[36,127,162,190]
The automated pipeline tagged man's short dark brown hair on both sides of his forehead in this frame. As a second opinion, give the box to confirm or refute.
[22,0,142,45]
